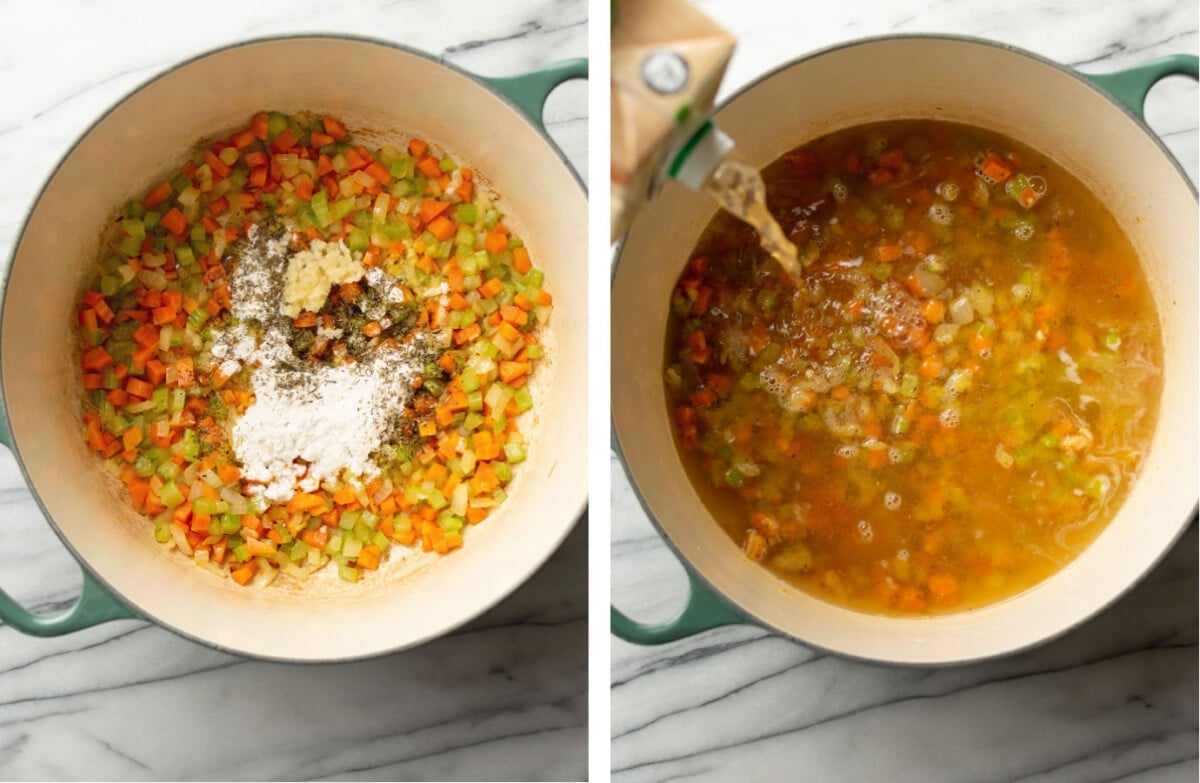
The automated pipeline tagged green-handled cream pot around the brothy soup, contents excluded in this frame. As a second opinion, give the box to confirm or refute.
[612,36,1198,664]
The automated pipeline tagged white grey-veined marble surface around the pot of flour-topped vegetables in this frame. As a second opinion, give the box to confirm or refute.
[0,0,587,779]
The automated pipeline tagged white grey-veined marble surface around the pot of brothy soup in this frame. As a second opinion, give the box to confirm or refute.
[612,0,1198,783]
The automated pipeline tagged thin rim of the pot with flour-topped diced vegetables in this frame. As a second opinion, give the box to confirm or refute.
[0,32,588,665]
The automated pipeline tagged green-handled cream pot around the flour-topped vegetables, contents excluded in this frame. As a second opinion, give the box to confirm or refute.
[0,36,587,662]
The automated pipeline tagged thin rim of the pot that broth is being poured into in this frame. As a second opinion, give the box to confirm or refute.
[610,32,1200,669]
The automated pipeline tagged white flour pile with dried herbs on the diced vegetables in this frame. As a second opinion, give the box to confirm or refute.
[212,226,434,502]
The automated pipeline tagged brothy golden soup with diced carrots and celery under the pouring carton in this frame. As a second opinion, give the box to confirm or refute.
[665,120,1162,614]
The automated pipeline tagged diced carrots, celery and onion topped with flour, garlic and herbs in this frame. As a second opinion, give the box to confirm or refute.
[78,112,552,585]
